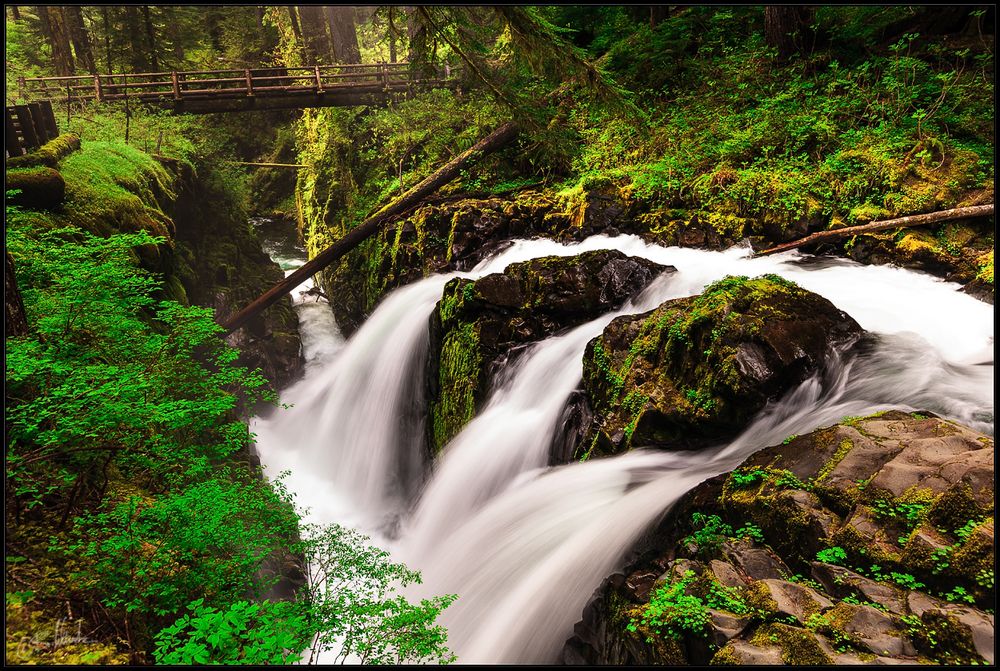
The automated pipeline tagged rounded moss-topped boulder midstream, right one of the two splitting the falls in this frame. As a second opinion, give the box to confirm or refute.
[582,275,863,454]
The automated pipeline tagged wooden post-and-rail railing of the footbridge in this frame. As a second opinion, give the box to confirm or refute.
[18,63,451,102]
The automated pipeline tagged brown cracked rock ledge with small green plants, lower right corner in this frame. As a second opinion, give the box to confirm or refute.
[564,411,995,665]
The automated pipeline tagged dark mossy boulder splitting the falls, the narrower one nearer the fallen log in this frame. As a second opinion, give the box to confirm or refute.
[428,250,672,453]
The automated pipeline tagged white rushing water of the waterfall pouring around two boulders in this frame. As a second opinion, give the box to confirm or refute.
[253,236,994,663]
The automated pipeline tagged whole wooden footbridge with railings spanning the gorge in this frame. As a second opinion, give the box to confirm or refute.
[17,63,458,114]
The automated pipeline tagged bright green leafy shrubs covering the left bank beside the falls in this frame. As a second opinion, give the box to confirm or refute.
[6,209,454,664]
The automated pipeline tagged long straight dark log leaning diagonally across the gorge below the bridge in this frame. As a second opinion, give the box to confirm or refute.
[222,122,517,335]
